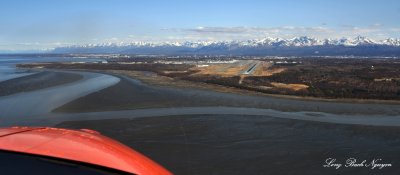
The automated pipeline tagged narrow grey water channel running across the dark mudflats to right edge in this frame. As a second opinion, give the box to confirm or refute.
[49,106,400,127]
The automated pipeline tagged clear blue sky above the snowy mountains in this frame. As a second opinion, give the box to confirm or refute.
[0,0,400,50]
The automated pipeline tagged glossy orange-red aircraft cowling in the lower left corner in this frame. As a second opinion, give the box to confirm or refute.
[0,127,172,175]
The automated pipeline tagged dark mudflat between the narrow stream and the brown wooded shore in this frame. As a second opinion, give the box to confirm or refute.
[45,70,400,116]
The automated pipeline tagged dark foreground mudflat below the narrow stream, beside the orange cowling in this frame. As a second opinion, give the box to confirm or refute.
[56,115,400,175]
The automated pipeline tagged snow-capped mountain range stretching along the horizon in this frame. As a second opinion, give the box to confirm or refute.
[52,36,400,56]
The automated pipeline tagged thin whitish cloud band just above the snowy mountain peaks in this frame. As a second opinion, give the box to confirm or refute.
[163,23,399,40]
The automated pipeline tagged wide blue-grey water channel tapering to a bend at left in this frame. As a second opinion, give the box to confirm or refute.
[0,71,120,121]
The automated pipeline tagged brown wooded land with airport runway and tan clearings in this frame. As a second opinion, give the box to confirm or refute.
[19,58,400,100]
